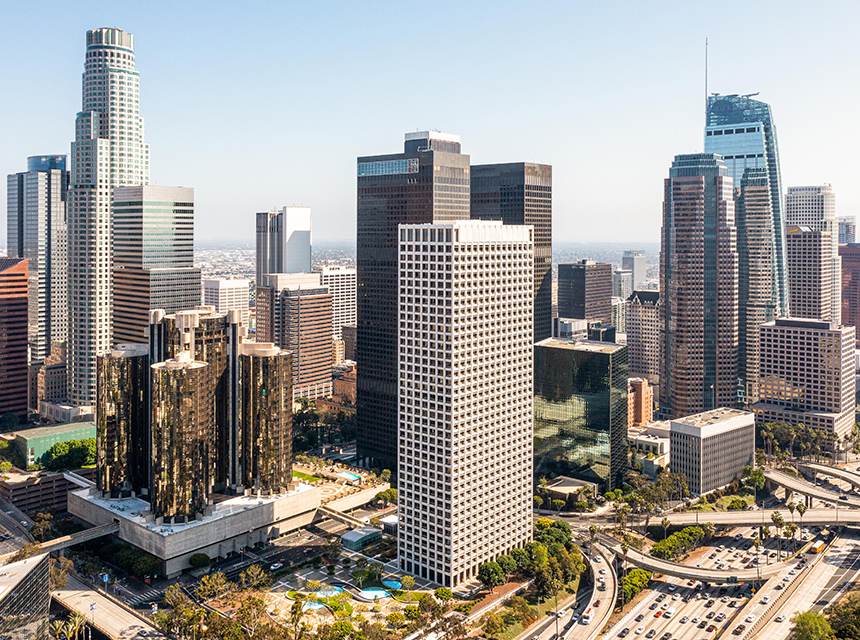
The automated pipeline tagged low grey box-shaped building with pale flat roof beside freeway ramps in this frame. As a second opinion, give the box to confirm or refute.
[669,408,755,496]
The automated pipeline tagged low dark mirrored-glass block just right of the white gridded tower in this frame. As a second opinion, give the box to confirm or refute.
[534,338,629,491]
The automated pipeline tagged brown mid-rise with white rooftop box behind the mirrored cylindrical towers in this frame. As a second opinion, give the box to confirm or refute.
[257,273,334,399]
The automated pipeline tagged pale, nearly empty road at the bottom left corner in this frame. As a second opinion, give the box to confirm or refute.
[51,575,167,640]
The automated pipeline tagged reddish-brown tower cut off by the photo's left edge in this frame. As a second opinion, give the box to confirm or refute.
[0,257,29,418]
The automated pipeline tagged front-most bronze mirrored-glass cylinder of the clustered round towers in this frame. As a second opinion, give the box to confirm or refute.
[150,351,217,523]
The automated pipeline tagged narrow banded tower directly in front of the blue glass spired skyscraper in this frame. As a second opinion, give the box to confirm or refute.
[735,169,776,405]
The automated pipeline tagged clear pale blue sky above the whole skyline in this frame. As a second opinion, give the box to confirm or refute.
[0,0,860,243]
